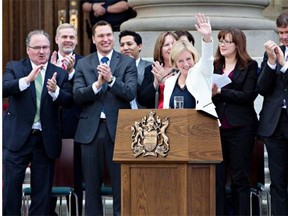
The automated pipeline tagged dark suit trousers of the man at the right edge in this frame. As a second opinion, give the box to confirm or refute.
[264,109,288,215]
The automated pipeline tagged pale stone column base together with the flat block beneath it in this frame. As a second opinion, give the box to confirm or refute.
[115,0,282,59]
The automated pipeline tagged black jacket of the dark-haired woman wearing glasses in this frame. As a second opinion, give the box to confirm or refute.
[213,60,258,127]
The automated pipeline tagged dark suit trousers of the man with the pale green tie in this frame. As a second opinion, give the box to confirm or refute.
[3,134,55,215]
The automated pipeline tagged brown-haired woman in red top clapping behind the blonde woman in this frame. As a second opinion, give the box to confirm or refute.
[137,32,178,109]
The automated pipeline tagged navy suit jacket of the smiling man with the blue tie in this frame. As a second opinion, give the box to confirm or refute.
[73,50,137,143]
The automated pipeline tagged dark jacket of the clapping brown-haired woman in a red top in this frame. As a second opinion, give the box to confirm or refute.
[137,65,156,108]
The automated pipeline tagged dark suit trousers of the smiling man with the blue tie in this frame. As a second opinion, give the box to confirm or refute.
[81,121,121,215]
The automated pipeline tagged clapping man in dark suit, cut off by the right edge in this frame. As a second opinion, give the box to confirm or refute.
[257,11,288,215]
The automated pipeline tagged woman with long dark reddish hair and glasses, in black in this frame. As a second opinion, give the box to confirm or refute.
[212,28,258,215]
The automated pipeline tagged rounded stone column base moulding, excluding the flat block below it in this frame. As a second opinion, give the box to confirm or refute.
[121,0,275,31]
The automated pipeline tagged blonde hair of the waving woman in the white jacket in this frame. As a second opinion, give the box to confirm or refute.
[169,40,199,67]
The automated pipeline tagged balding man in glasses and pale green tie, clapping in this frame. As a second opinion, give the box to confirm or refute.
[3,30,73,215]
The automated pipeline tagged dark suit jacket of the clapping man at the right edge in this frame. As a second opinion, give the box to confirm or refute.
[257,46,288,137]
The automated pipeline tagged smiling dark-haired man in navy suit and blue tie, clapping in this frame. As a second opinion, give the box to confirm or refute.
[73,21,137,215]
